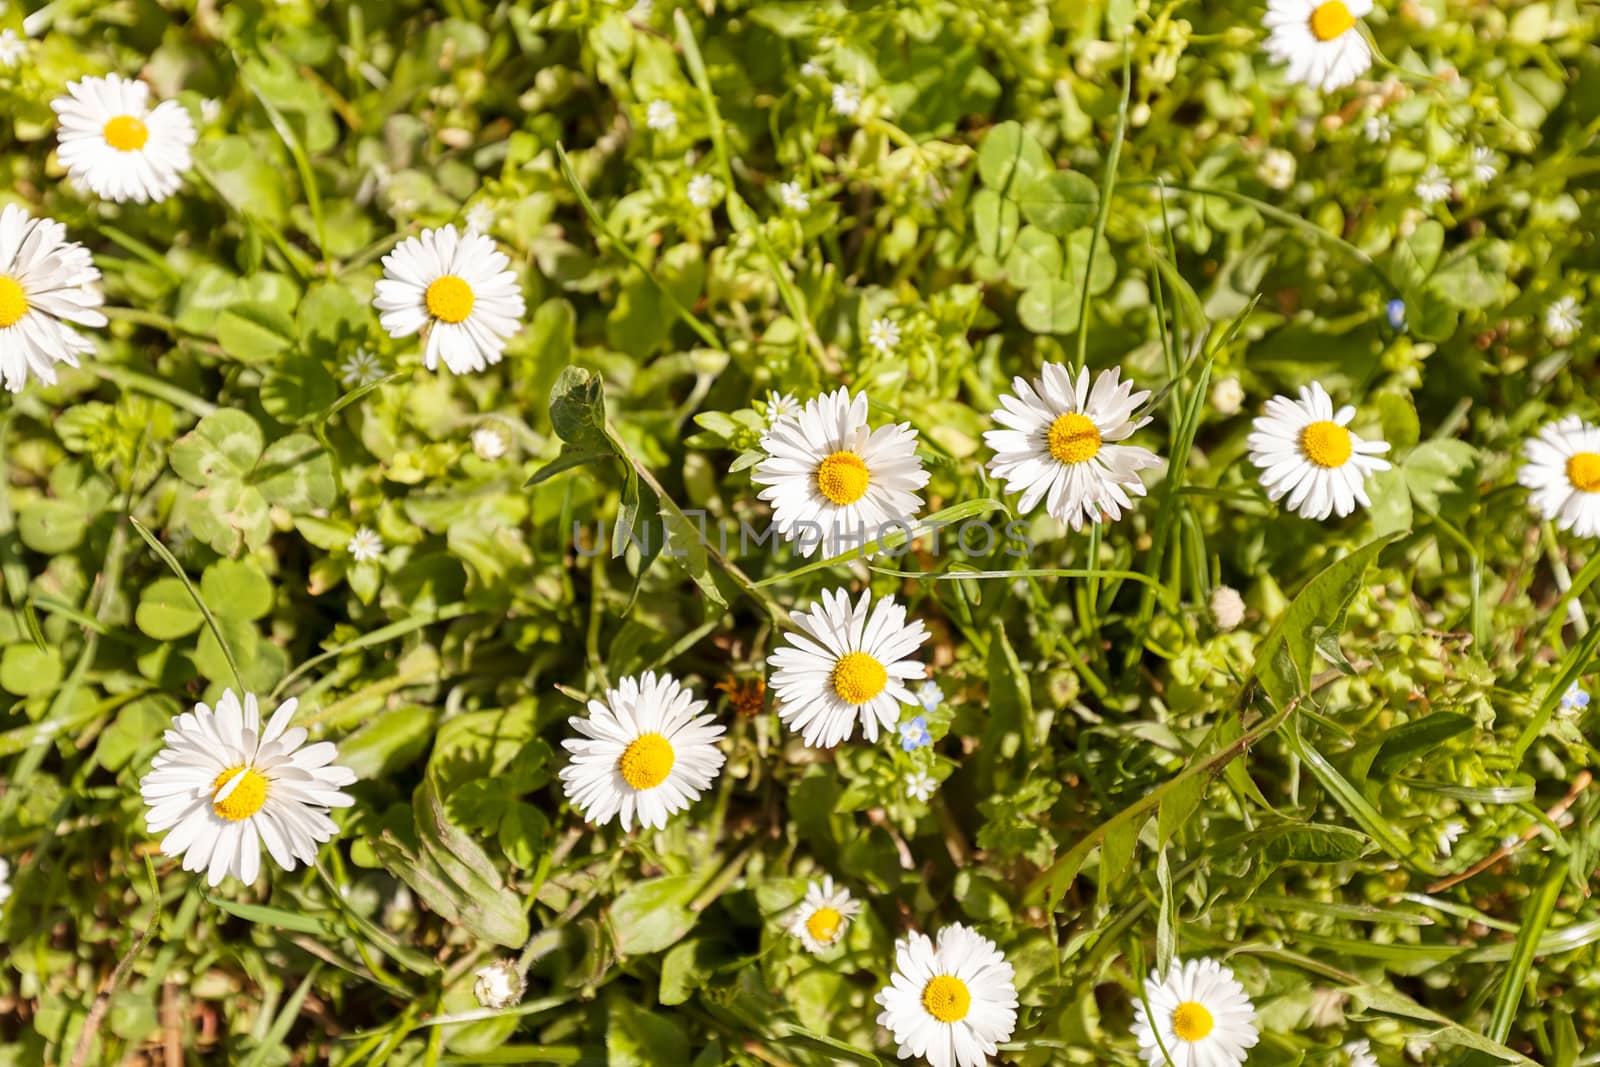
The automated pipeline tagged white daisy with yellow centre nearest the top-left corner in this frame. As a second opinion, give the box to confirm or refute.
[50,74,195,203]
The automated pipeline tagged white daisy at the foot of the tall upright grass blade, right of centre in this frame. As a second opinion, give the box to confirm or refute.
[984,363,1160,530]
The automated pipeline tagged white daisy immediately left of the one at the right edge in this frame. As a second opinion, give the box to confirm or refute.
[1245,382,1389,520]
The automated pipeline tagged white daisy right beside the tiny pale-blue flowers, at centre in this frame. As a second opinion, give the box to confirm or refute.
[766,589,928,749]
